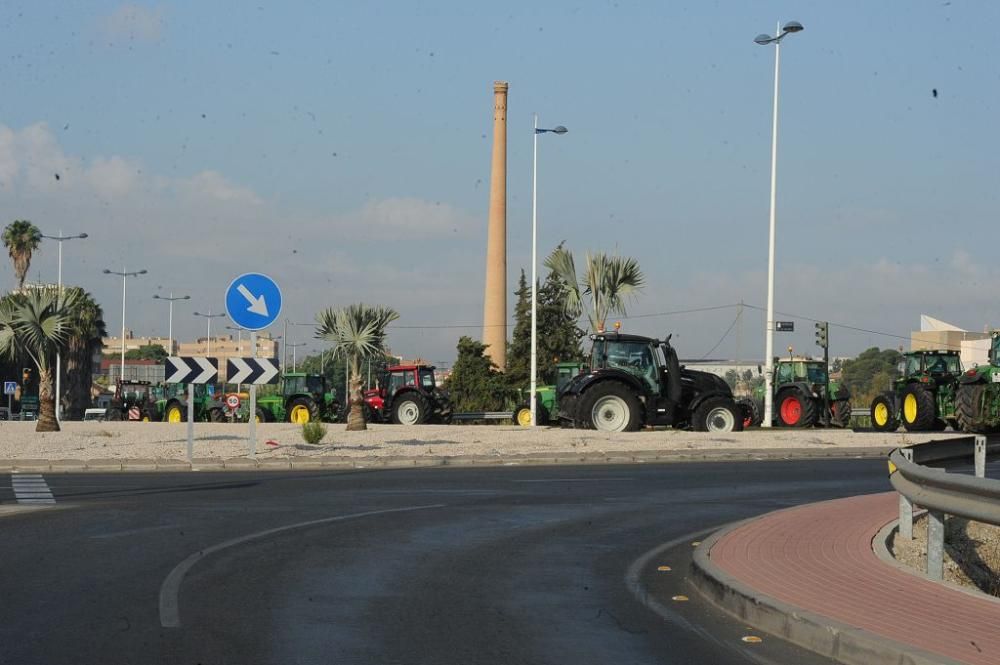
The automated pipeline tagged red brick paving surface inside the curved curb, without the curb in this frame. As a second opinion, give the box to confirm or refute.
[710,492,1000,665]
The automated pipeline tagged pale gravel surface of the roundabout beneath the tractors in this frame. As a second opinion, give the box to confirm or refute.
[0,421,968,460]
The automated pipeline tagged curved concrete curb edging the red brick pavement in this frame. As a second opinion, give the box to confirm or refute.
[691,517,960,665]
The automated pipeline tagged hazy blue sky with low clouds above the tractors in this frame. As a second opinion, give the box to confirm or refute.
[0,0,1000,362]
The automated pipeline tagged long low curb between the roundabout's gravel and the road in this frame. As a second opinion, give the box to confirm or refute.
[0,447,892,473]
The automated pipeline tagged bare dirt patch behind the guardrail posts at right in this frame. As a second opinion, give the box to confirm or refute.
[889,514,1000,597]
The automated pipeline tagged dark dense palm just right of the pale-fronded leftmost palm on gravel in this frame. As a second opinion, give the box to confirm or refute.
[62,288,107,420]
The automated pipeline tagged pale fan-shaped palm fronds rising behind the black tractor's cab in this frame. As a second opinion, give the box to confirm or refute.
[545,243,646,331]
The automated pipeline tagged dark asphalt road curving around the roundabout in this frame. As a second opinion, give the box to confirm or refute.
[0,460,889,665]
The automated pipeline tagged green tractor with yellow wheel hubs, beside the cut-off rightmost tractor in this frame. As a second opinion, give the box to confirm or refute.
[871,351,962,432]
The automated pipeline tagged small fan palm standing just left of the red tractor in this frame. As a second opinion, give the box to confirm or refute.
[316,303,399,432]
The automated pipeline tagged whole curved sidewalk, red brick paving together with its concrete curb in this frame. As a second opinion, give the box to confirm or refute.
[694,492,1000,665]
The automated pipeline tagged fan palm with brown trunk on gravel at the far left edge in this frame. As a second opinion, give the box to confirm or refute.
[0,289,79,432]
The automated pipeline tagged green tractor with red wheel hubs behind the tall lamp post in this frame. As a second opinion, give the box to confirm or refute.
[740,358,851,427]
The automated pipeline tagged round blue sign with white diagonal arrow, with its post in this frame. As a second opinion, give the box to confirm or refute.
[226,272,281,457]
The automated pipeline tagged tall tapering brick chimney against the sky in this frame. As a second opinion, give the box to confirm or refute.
[483,81,507,371]
